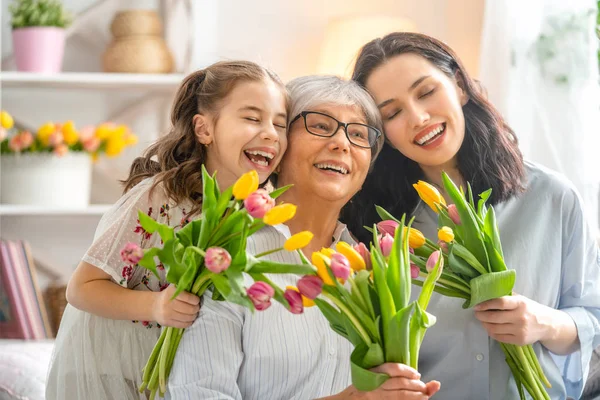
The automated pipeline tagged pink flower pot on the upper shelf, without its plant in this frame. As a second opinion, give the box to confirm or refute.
[12,26,65,73]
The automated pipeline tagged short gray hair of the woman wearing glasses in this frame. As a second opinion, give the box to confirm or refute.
[286,75,385,158]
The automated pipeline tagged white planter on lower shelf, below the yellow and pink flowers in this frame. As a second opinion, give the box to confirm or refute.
[0,152,92,208]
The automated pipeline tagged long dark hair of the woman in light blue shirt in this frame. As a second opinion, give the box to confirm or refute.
[342,32,525,243]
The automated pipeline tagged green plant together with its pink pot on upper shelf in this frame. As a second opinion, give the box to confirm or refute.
[9,0,71,73]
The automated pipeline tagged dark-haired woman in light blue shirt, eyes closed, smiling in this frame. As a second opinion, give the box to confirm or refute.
[343,33,600,400]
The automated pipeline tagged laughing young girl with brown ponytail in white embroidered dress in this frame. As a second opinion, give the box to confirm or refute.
[46,61,287,400]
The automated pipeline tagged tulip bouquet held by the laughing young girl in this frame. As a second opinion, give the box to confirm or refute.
[128,168,315,399]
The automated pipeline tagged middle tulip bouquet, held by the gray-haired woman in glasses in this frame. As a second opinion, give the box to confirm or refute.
[288,216,444,391]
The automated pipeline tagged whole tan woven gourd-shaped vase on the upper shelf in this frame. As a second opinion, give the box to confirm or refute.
[103,10,174,74]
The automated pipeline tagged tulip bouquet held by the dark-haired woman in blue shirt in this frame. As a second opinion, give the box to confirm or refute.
[406,173,550,400]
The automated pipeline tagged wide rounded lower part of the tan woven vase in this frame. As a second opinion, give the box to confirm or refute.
[103,36,173,74]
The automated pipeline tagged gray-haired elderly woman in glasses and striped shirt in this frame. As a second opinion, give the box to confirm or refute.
[167,76,439,400]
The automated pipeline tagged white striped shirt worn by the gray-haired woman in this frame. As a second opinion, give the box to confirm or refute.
[166,223,353,400]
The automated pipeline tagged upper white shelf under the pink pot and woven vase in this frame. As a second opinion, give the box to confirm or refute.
[0,71,185,91]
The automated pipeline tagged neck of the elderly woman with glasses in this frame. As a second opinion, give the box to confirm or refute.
[279,187,343,258]
